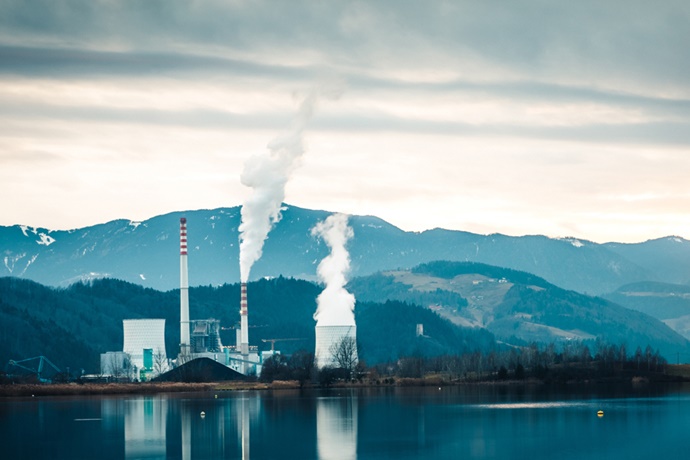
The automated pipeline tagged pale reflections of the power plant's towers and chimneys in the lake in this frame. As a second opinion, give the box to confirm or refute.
[112,395,358,460]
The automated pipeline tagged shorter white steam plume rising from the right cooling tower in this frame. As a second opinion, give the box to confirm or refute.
[311,214,355,326]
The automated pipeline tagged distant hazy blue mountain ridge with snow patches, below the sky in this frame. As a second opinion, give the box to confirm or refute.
[0,205,690,294]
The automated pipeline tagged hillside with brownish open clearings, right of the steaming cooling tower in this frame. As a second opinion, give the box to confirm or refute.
[349,262,690,356]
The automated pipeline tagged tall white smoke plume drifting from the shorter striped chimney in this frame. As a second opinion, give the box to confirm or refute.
[239,83,341,283]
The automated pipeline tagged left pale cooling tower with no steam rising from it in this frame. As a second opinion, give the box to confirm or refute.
[122,319,167,369]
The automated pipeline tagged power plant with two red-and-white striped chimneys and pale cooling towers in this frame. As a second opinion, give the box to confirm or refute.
[101,213,358,380]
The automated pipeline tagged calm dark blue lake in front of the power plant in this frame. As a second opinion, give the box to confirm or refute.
[0,385,690,460]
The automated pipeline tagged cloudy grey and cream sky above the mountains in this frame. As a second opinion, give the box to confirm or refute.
[0,0,690,243]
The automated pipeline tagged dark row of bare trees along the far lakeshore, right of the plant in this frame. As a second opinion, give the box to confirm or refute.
[260,340,667,386]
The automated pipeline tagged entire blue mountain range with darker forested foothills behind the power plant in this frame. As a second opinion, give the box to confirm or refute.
[0,205,690,361]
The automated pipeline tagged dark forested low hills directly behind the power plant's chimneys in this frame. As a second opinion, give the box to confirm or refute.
[0,277,494,372]
